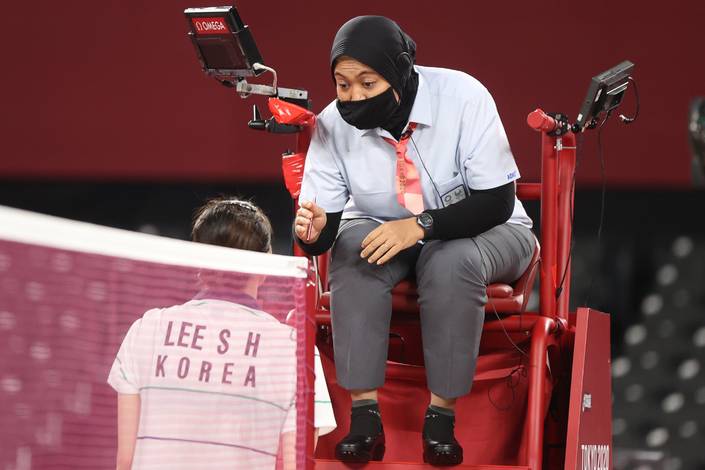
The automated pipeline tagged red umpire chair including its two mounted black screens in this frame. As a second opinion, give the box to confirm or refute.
[185,7,620,470]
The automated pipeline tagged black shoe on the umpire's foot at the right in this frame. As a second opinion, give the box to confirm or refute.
[423,409,463,466]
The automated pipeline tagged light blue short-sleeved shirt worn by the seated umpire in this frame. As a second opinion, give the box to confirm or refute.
[299,66,532,227]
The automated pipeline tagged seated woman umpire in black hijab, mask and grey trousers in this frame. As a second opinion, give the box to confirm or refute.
[294,16,534,465]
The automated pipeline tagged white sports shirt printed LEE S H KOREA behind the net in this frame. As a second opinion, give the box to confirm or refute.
[108,299,335,470]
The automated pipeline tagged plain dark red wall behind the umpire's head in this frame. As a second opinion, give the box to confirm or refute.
[0,0,705,187]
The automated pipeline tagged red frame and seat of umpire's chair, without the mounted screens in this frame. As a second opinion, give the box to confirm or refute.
[270,98,612,470]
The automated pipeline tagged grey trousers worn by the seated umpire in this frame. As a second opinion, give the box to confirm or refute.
[330,219,535,399]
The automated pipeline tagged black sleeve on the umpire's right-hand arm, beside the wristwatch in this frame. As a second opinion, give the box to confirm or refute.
[424,181,516,240]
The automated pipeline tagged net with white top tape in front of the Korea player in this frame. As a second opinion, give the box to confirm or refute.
[0,208,312,470]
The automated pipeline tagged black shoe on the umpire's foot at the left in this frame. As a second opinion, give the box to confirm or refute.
[335,405,385,463]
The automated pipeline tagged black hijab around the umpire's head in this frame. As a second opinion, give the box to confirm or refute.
[330,16,419,139]
